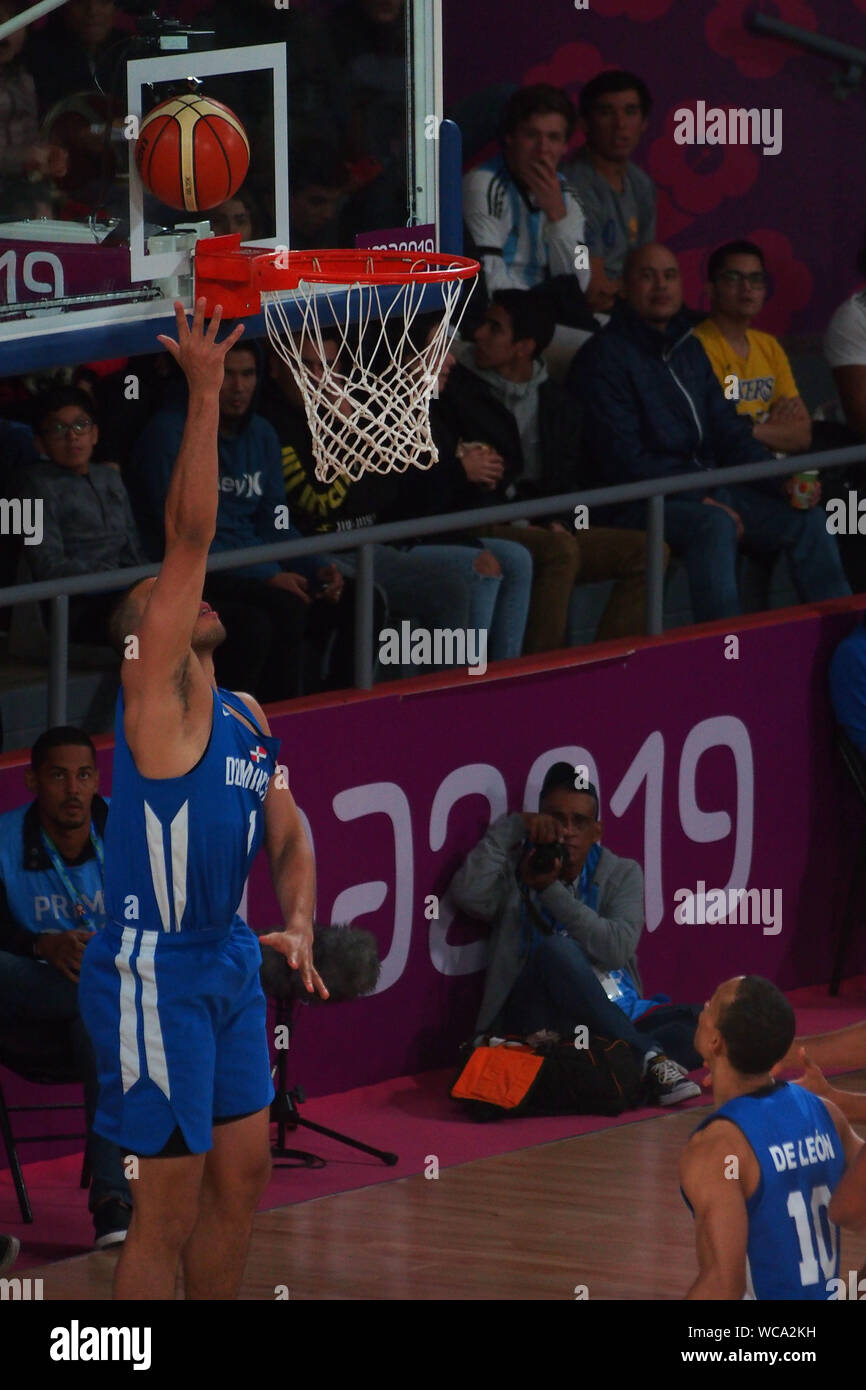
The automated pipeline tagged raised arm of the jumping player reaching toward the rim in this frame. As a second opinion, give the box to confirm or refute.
[124,300,243,695]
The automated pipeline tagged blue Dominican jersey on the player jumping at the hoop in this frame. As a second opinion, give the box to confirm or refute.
[106,689,279,941]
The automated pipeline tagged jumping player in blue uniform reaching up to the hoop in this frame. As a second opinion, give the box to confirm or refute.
[79,302,327,1298]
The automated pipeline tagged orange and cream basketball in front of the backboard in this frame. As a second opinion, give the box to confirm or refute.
[135,93,250,213]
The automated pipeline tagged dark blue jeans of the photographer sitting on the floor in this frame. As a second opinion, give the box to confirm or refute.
[502,935,701,1070]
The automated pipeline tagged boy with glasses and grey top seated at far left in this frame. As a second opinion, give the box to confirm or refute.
[21,386,147,644]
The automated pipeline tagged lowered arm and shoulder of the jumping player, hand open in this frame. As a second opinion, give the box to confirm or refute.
[233,695,328,999]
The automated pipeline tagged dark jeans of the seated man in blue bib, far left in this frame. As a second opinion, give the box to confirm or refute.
[0,951,132,1211]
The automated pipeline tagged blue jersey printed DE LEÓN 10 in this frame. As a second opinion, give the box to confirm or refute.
[694,1081,845,1300]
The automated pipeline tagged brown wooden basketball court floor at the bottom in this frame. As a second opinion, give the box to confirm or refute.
[26,1070,866,1301]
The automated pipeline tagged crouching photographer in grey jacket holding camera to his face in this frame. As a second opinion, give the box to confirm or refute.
[449,763,701,1105]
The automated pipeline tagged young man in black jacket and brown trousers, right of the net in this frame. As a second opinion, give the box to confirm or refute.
[444,289,667,652]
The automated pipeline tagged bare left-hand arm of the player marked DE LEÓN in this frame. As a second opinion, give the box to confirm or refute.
[680,1120,749,1300]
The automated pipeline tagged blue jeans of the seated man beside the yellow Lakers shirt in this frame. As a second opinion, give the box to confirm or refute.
[612,486,851,623]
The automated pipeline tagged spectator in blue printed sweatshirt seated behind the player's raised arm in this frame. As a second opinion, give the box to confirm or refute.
[128,342,353,701]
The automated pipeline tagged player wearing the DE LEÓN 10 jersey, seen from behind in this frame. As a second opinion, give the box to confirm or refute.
[680,974,863,1300]
